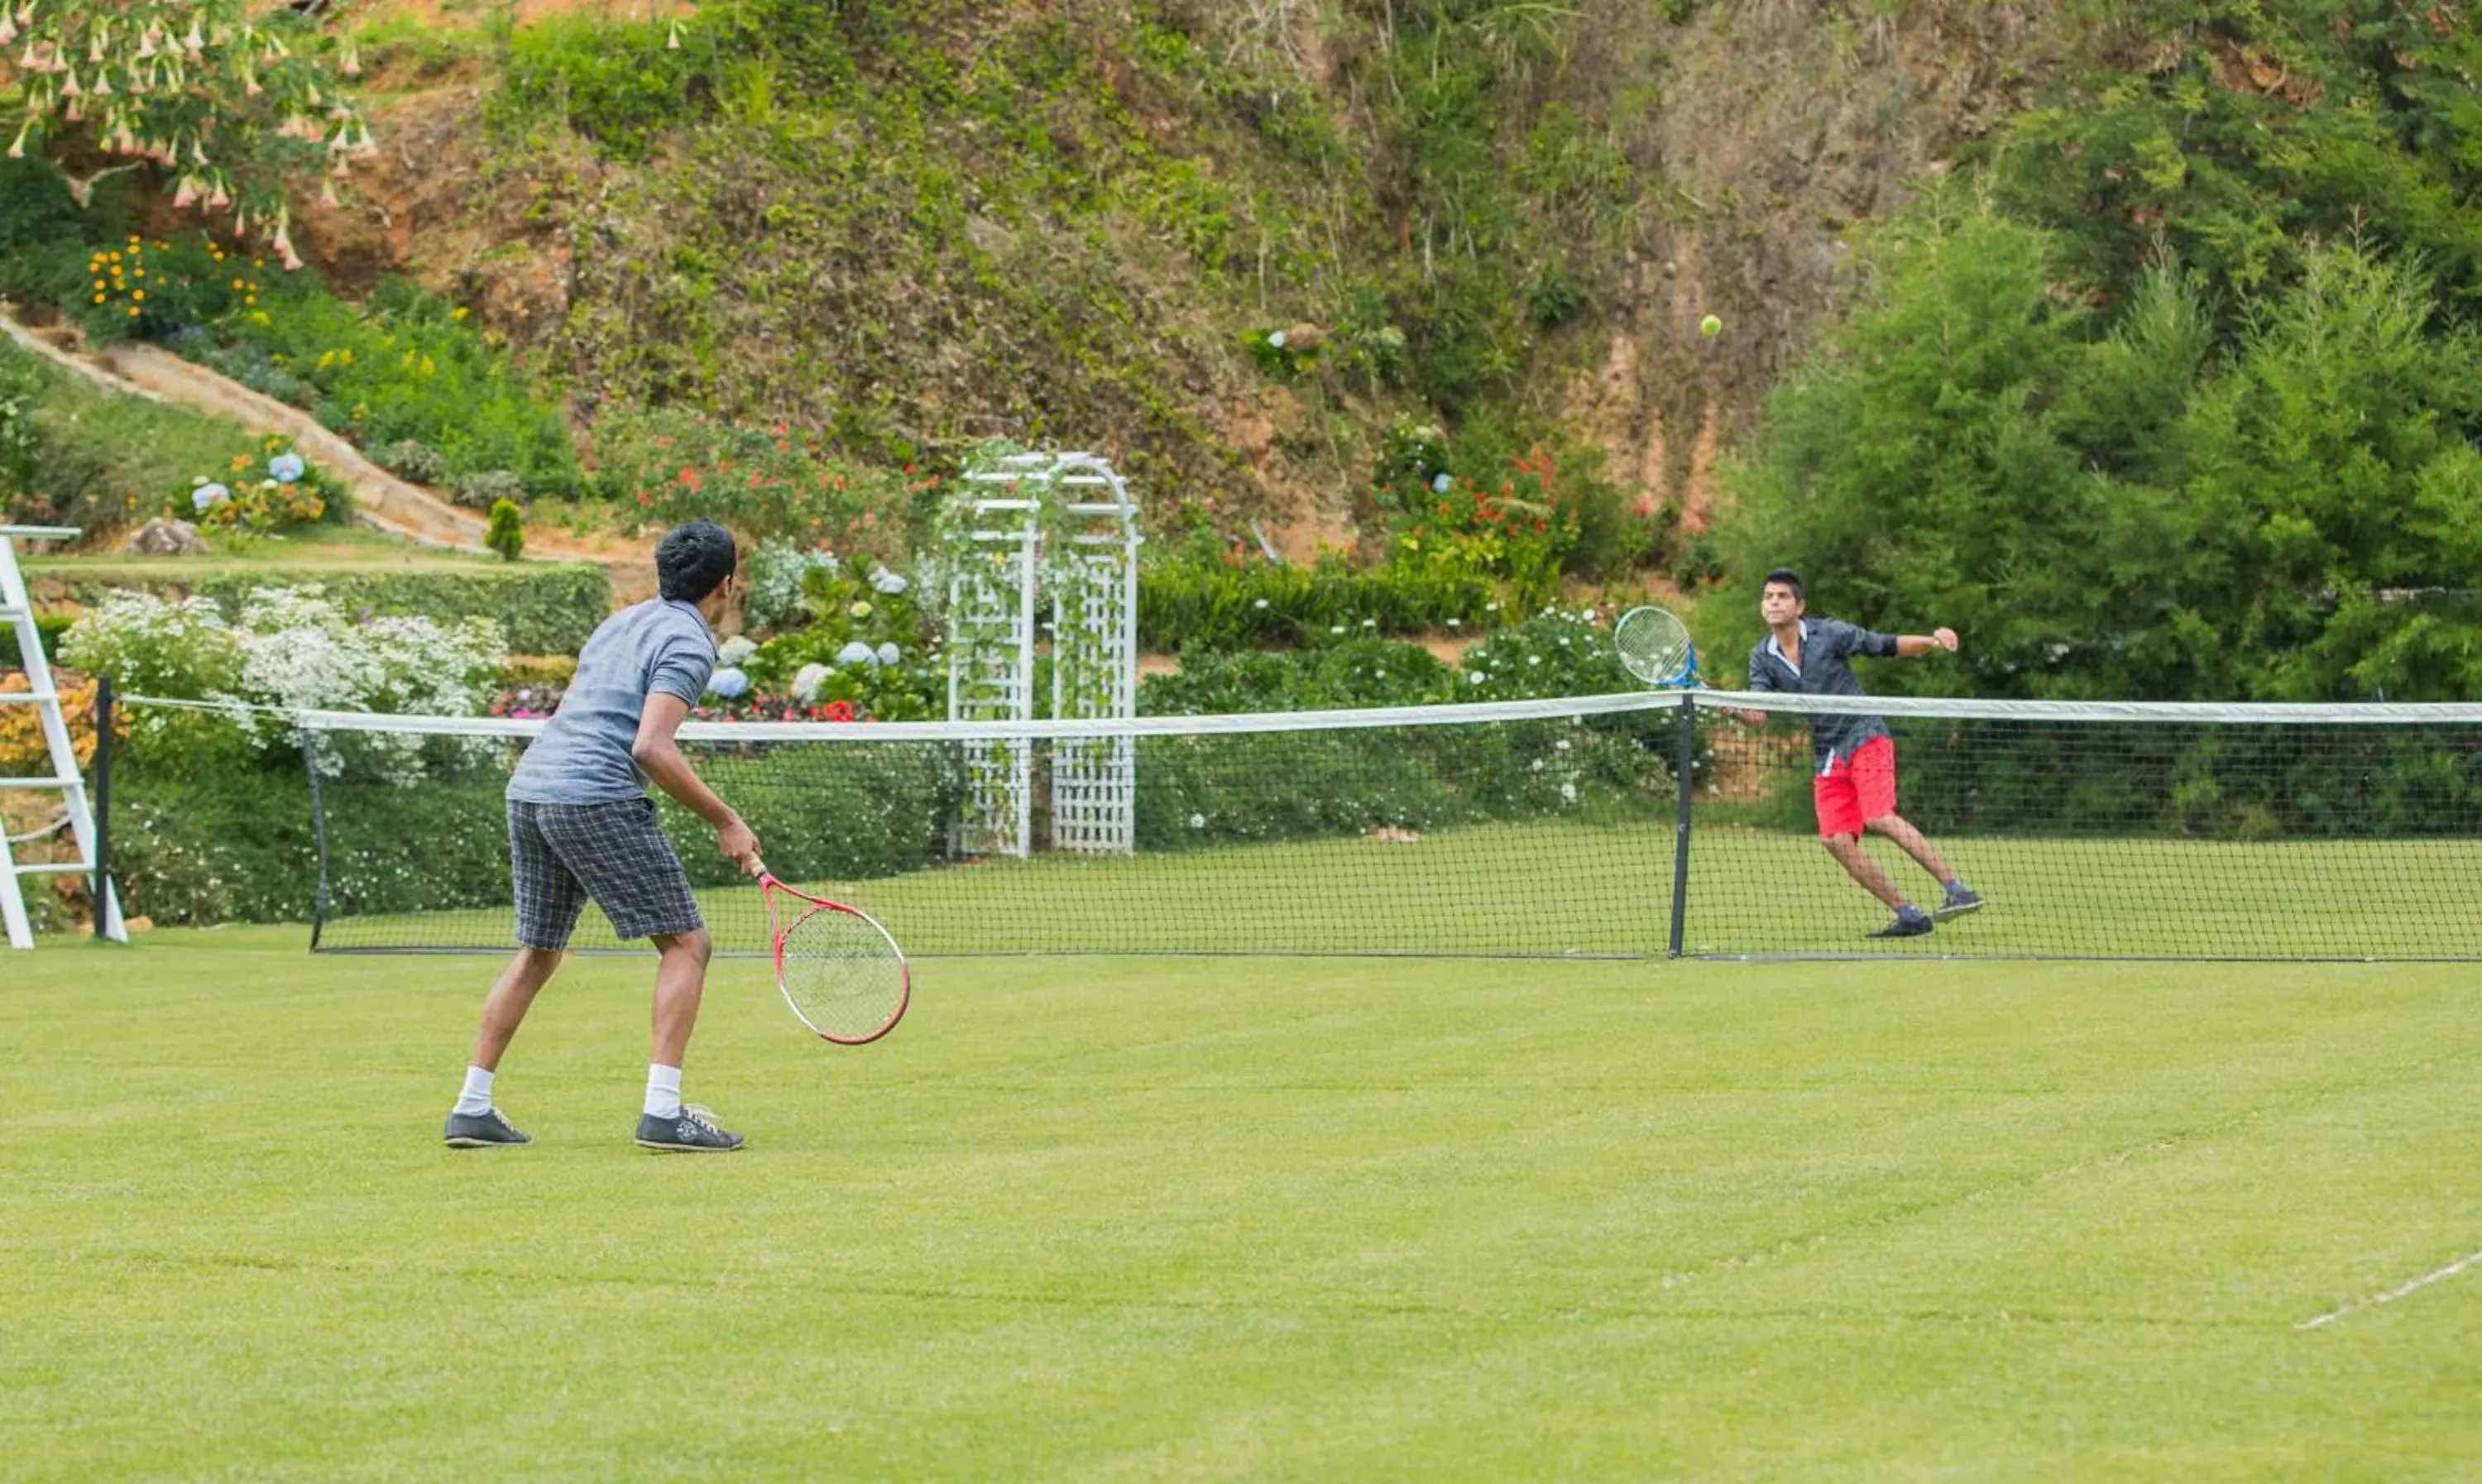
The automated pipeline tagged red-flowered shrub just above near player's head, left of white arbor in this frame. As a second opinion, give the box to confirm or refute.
[596,407,936,551]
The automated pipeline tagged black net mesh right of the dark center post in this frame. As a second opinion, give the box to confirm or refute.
[1683,697,2482,958]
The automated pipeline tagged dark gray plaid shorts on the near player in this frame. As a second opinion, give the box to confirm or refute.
[509,799,705,953]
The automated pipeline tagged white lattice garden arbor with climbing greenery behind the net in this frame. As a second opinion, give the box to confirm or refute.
[948,454,1144,856]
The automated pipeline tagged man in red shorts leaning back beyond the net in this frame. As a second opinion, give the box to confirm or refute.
[1745,568,1983,938]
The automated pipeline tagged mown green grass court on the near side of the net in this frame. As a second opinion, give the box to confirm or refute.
[0,928,2482,1482]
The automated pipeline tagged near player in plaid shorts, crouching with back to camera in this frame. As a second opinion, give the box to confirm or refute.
[447,521,759,1151]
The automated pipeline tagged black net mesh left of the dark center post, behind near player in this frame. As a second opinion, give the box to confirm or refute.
[295,707,1678,955]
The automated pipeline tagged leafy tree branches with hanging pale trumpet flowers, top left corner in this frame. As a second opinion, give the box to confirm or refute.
[0,0,375,268]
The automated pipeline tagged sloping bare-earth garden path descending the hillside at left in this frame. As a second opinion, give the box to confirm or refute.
[0,308,655,603]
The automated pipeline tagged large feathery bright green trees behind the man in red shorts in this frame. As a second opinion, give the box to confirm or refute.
[1725,211,2482,700]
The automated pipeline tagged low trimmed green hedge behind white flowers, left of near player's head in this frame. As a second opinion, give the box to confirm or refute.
[27,561,613,655]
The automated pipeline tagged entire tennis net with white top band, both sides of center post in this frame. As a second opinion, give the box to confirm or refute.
[281,692,2482,960]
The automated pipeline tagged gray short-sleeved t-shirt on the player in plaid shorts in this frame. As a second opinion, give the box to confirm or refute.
[509,598,715,804]
